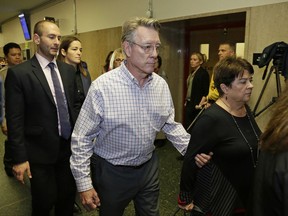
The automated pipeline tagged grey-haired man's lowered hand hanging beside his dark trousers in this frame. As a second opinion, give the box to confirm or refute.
[79,188,100,211]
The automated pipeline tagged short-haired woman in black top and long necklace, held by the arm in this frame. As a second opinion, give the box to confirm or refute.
[178,58,261,216]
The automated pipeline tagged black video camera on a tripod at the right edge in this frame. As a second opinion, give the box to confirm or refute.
[258,41,288,79]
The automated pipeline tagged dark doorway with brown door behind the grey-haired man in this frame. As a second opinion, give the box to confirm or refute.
[160,12,246,122]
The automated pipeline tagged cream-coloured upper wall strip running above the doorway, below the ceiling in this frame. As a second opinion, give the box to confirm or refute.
[0,0,287,46]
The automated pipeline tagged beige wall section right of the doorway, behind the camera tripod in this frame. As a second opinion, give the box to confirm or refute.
[245,2,288,129]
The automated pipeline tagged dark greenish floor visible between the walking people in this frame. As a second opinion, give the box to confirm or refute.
[0,138,183,216]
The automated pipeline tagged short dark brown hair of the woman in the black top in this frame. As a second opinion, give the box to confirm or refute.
[213,57,254,96]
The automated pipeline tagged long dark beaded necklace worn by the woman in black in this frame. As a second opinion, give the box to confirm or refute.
[220,99,259,168]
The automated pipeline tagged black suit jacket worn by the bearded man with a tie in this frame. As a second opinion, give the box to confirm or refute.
[5,56,76,164]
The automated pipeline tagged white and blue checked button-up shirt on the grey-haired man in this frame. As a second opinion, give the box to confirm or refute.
[70,63,190,192]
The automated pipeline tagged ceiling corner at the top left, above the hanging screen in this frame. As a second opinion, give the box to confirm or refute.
[0,0,63,26]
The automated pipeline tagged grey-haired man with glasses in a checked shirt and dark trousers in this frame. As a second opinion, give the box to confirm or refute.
[70,18,190,216]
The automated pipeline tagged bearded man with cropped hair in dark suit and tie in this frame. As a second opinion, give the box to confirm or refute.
[5,21,76,216]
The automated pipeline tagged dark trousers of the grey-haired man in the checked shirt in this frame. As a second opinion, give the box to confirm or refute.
[91,154,159,216]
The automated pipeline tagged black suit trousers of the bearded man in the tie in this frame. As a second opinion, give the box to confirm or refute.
[30,139,76,216]
